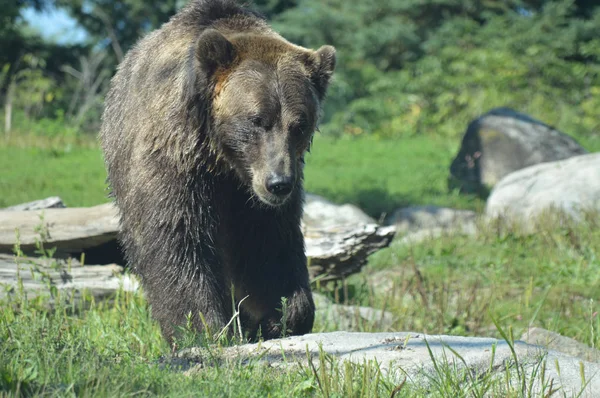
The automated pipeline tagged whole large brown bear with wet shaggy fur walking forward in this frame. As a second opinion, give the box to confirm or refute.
[100,0,335,339]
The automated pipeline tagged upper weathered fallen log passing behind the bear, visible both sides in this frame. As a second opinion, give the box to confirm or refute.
[0,203,396,281]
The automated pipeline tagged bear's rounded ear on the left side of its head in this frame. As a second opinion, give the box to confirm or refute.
[196,29,236,76]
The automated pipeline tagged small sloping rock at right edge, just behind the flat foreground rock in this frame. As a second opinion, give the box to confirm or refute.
[521,328,600,362]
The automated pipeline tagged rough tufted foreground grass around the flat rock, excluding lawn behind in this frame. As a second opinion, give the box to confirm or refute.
[0,214,600,397]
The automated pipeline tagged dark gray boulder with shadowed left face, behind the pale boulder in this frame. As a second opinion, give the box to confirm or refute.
[450,108,587,193]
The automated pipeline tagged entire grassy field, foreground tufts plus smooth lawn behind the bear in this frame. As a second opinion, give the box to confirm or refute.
[0,136,600,397]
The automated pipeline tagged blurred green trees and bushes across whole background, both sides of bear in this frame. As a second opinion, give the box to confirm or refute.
[0,0,600,138]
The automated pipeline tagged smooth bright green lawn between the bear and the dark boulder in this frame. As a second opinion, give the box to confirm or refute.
[306,136,483,217]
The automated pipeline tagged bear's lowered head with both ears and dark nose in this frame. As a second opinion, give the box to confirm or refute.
[196,29,335,207]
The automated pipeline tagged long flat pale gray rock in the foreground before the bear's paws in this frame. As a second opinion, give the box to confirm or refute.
[167,332,600,397]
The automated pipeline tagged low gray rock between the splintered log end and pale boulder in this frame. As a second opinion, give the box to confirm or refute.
[386,206,477,232]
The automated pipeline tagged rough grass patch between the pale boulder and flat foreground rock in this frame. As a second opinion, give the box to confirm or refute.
[333,214,600,347]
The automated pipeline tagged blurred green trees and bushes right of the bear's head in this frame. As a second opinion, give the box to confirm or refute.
[275,0,600,137]
